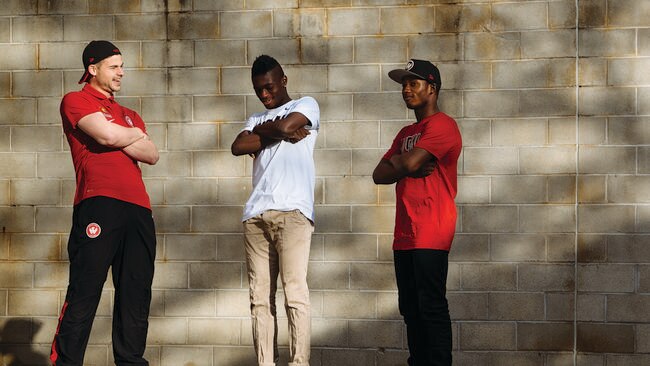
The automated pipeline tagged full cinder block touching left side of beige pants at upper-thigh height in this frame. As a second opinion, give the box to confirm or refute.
[189,262,244,289]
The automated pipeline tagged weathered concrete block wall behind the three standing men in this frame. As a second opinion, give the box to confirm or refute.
[0,0,650,366]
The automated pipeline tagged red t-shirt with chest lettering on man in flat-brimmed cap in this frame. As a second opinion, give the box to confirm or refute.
[384,112,462,251]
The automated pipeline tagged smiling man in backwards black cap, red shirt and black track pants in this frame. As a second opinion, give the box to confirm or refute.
[50,41,158,366]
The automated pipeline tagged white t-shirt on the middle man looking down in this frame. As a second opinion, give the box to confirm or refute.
[242,97,320,222]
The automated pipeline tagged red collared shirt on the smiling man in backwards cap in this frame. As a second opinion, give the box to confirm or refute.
[60,84,151,209]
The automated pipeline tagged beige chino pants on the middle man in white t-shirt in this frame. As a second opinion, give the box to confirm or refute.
[244,210,314,366]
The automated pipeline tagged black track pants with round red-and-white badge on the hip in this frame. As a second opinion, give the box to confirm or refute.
[50,197,156,366]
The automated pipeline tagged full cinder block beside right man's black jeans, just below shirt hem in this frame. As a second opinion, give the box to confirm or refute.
[458,263,517,291]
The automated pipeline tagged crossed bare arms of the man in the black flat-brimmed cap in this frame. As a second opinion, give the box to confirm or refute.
[372,147,437,184]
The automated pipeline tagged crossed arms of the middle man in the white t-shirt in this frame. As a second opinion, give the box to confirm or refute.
[230,112,310,156]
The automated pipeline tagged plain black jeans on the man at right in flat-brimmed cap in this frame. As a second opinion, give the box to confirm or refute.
[394,249,452,366]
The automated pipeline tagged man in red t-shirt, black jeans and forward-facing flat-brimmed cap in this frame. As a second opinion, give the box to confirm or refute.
[372,59,462,366]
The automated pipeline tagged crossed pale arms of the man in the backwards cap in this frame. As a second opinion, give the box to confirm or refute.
[77,112,159,165]
